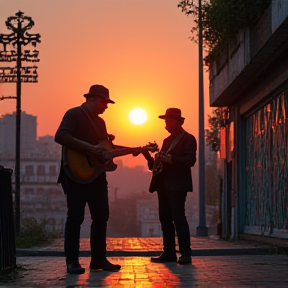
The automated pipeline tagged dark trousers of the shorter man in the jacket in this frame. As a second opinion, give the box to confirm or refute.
[157,189,191,255]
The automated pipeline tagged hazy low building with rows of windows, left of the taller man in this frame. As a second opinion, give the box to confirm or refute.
[0,153,66,234]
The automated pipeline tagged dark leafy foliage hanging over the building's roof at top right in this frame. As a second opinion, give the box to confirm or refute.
[178,0,271,65]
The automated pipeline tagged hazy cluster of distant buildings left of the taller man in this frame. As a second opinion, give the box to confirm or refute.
[0,112,66,231]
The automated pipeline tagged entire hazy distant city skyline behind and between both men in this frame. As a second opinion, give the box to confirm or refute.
[0,112,197,237]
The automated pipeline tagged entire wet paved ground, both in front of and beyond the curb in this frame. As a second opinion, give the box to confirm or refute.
[0,237,288,288]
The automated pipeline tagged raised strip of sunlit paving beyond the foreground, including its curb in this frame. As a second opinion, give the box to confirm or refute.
[17,236,280,257]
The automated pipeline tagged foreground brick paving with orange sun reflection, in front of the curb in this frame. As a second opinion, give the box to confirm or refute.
[0,254,288,288]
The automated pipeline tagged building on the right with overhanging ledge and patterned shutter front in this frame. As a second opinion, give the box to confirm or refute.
[210,0,288,238]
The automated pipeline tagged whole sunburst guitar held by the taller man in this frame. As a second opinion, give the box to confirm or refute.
[64,140,158,184]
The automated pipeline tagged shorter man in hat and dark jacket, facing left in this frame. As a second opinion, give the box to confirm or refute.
[143,108,197,264]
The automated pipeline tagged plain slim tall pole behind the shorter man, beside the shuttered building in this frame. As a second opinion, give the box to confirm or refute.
[196,0,208,236]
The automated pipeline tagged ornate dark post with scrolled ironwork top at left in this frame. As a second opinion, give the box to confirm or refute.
[0,11,41,235]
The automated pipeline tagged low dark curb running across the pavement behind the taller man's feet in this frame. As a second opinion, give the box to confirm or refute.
[16,247,279,257]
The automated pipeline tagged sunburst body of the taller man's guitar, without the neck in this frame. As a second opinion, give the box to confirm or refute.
[64,140,117,184]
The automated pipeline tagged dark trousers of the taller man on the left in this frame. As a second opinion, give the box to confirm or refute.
[61,174,109,262]
